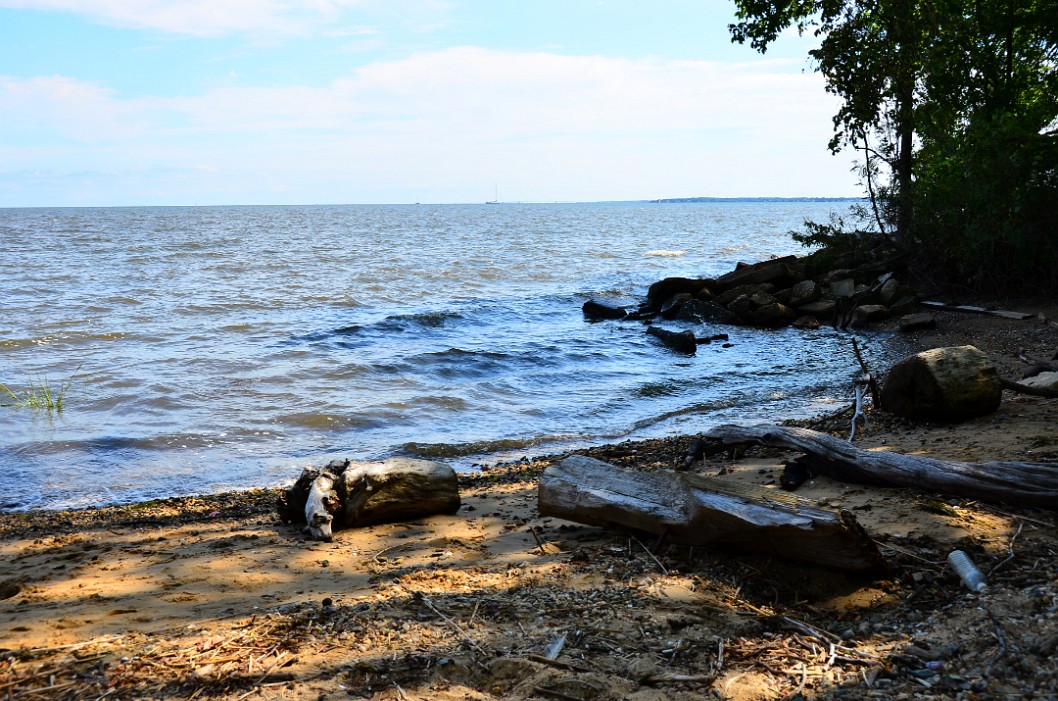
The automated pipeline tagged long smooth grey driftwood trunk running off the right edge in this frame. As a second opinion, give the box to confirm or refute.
[705,425,1058,509]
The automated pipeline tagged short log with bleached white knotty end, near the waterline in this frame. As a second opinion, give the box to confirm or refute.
[277,458,460,540]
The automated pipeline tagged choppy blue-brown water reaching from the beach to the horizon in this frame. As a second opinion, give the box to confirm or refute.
[0,202,897,509]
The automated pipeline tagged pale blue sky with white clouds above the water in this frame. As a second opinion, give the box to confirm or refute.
[0,0,861,206]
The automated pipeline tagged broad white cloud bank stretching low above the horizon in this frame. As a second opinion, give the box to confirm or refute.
[0,47,853,202]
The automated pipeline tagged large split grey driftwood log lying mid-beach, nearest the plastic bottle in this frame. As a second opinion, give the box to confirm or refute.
[539,456,886,571]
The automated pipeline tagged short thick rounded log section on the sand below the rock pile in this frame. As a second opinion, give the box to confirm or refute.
[880,346,1003,423]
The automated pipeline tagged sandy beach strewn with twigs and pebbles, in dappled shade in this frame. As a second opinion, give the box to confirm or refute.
[0,300,1058,701]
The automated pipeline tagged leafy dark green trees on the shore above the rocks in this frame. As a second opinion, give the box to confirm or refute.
[730,0,1058,292]
